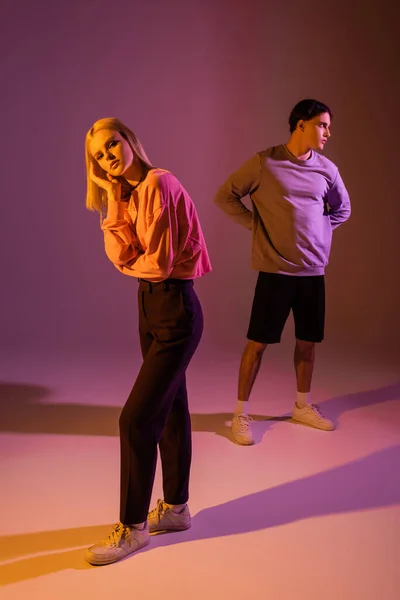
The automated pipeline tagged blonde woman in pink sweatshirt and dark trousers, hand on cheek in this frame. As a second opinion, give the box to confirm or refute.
[86,118,211,565]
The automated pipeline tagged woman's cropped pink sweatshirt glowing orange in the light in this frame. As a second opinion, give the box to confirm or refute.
[101,169,211,282]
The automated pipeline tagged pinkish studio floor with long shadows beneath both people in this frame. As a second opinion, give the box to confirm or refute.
[0,345,400,600]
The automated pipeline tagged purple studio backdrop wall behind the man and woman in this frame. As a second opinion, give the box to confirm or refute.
[0,0,400,354]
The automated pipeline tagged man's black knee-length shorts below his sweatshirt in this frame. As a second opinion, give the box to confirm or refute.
[247,273,325,344]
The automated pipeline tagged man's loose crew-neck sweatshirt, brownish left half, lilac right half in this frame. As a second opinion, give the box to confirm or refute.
[215,145,351,276]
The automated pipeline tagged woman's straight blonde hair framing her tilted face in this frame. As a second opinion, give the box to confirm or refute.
[85,117,153,215]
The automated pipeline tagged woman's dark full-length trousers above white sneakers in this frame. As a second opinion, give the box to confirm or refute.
[119,279,203,525]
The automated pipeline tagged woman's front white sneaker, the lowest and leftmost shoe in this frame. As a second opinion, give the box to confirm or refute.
[85,523,150,565]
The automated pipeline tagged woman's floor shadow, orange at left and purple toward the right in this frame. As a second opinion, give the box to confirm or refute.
[0,445,400,585]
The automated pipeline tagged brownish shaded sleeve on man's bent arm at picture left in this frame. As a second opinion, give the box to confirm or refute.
[214,154,261,229]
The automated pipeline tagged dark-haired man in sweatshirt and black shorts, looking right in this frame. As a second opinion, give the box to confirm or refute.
[215,100,350,445]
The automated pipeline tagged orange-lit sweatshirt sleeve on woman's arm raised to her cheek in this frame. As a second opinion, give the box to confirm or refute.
[101,201,140,267]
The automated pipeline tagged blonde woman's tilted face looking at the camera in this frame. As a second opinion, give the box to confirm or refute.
[90,129,134,177]
